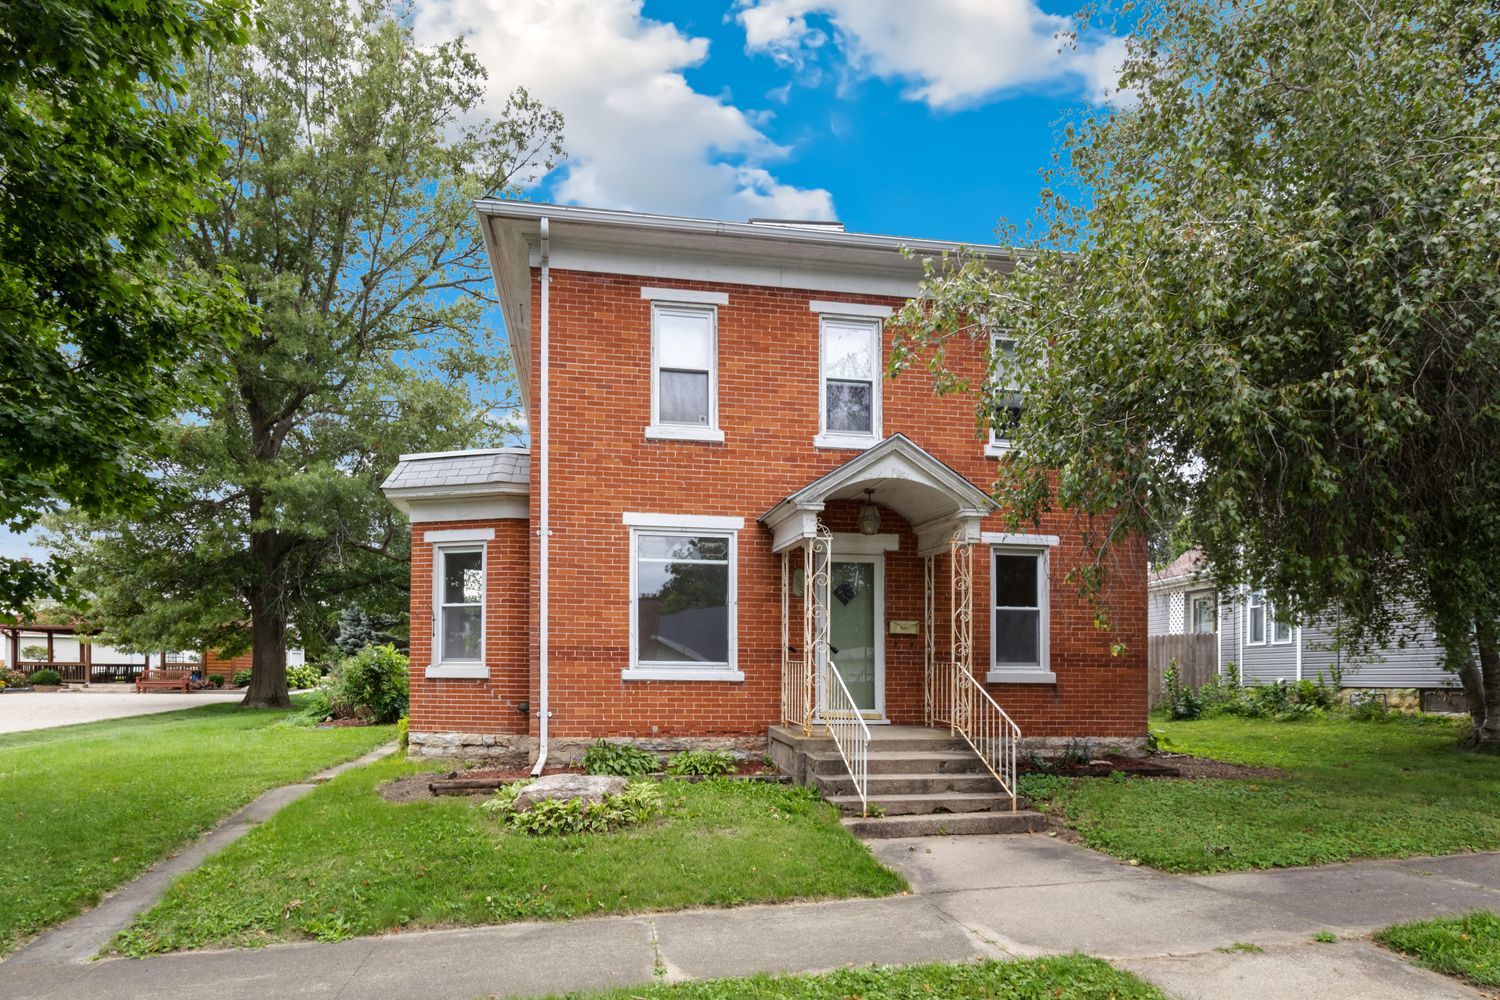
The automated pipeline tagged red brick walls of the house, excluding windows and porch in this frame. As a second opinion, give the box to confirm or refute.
[504,270,1146,738]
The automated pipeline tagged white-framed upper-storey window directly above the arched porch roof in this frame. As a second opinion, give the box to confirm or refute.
[813,315,882,448]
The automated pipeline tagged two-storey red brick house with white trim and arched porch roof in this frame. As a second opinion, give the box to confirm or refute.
[386,201,1146,803]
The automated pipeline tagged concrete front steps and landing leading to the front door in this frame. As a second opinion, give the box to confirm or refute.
[770,726,1047,837]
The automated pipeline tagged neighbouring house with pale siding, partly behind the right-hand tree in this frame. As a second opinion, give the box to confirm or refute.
[1148,550,1461,711]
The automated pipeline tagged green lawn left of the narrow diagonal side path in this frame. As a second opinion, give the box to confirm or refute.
[0,694,392,955]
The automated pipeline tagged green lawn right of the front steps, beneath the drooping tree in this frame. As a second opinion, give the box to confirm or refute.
[1022,717,1500,873]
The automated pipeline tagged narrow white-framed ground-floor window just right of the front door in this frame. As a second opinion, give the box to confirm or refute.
[986,546,1058,684]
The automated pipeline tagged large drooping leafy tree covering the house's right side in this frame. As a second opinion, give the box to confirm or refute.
[896,0,1500,747]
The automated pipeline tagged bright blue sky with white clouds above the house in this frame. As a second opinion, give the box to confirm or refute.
[0,0,1122,556]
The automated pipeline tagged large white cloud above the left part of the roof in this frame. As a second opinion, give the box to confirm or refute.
[414,0,834,219]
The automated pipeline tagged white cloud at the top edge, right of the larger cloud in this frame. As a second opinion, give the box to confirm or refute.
[737,0,1124,109]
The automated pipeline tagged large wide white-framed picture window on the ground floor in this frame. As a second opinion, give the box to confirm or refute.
[621,514,744,681]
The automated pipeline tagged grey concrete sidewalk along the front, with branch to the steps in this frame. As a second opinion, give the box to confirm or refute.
[0,837,1500,1000]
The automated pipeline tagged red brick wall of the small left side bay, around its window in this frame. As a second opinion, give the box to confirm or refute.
[411,517,534,735]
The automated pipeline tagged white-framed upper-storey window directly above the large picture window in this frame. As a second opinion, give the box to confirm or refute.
[647,301,725,441]
